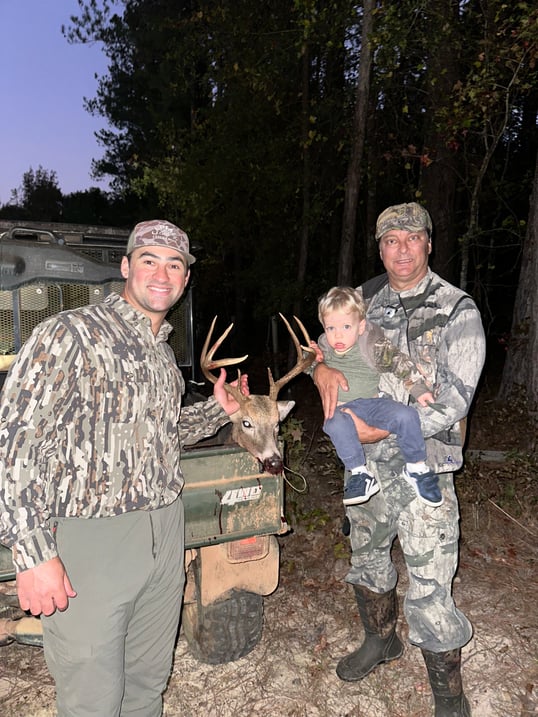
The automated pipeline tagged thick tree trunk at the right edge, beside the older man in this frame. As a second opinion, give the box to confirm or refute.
[499,148,538,411]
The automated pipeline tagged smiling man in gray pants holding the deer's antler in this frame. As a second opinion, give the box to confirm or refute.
[0,220,238,717]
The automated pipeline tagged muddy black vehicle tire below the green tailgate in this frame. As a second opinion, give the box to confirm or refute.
[182,590,263,665]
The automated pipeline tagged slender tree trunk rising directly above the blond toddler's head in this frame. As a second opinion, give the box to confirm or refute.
[337,0,375,285]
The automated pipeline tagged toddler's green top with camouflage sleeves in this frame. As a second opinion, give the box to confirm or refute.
[318,321,430,403]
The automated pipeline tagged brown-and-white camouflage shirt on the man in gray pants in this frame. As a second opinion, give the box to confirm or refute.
[0,294,229,570]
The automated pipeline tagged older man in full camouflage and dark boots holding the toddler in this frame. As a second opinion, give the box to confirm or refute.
[314,203,485,717]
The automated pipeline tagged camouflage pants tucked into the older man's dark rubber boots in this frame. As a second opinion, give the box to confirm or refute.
[346,441,472,652]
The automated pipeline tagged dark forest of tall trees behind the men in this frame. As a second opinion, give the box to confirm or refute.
[0,0,538,412]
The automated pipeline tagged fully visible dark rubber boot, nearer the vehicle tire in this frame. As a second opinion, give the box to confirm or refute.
[336,585,403,682]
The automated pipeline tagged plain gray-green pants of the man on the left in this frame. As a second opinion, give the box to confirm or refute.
[43,499,185,717]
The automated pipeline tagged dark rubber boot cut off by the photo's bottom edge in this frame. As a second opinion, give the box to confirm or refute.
[422,648,471,717]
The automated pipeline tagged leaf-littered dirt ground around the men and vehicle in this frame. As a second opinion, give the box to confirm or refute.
[0,364,538,717]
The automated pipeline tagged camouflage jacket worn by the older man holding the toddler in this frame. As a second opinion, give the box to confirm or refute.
[363,270,485,473]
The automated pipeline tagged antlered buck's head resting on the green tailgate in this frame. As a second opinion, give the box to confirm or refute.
[200,314,316,474]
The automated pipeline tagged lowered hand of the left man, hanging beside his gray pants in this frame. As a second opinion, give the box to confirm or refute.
[17,558,76,615]
